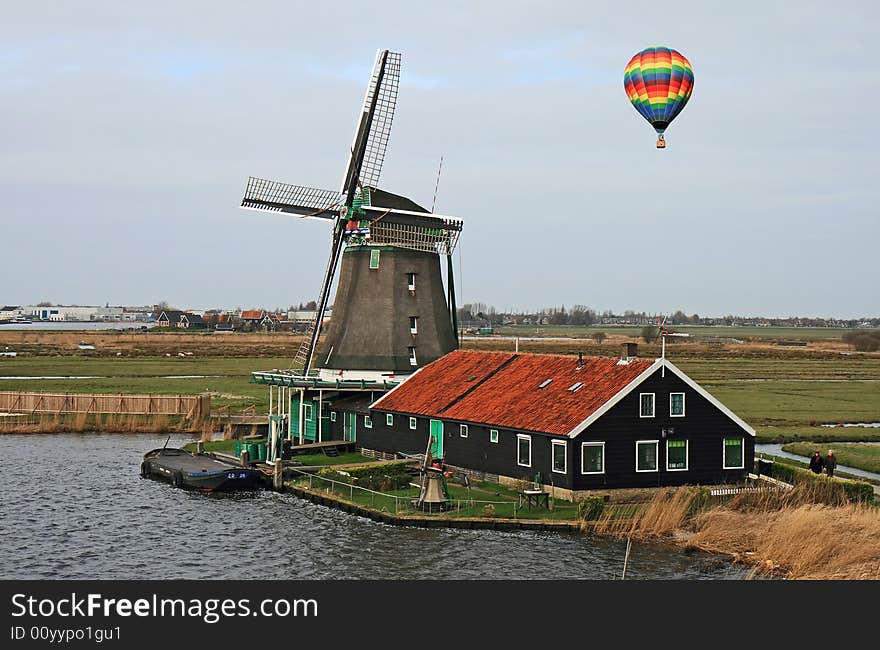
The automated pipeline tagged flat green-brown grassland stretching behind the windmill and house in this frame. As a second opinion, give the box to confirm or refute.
[0,328,880,442]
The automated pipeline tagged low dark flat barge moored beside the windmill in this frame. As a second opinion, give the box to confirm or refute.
[141,447,263,492]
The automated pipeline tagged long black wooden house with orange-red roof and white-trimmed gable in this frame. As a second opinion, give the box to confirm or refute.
[358,349,755,498]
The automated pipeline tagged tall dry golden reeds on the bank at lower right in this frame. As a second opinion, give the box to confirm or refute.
[583,481,880,580]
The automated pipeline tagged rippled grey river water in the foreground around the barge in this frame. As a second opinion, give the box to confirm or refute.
[0,434,746,580]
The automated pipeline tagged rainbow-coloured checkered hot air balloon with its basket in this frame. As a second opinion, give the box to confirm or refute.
[623,46,694,149]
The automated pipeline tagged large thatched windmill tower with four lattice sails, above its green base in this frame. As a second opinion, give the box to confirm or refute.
[241,50,462,377]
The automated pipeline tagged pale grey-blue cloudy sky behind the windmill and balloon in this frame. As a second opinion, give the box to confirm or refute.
[0,0,880,318]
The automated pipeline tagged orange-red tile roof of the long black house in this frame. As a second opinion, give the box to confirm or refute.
[373,350,655,435]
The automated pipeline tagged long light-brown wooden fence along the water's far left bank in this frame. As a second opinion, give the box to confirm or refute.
[0,391,211,420]
